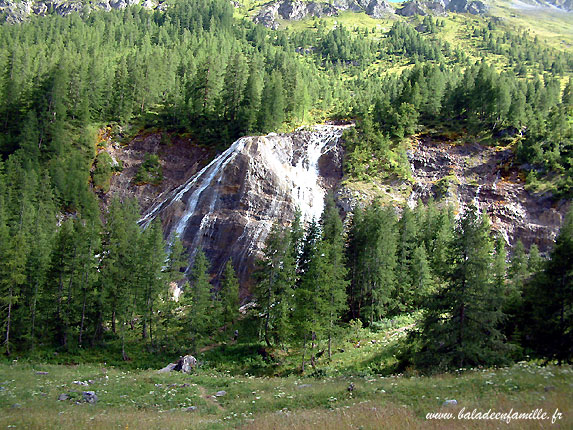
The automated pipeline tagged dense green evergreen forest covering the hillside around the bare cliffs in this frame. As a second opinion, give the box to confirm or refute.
[0,0,573,370]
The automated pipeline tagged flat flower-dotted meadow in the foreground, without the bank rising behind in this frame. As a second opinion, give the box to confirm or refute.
[0,363,573,429]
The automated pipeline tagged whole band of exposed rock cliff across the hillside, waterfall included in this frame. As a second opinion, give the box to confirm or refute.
[107,125,569,287]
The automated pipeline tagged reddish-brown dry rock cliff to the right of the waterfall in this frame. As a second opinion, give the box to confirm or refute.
[339,136,570,252]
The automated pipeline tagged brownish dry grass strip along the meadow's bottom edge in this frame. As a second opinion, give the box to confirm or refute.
[0,394,573,430]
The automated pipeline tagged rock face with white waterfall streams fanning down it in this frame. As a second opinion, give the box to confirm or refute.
[141,125,344,285]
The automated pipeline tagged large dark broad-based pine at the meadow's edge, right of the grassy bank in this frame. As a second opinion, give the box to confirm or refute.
[412,208,504,370]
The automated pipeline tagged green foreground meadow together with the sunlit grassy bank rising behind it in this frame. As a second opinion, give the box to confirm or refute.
[0,317,573,430]
